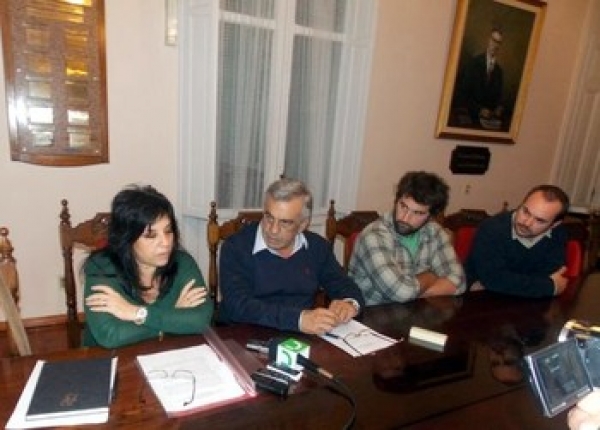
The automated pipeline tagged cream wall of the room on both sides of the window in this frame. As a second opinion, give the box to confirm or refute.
[0,0,591,317]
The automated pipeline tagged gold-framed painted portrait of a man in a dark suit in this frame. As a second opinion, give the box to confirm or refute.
[436,0,546,143]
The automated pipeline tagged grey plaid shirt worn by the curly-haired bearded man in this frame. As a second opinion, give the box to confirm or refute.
[349,212,466,305]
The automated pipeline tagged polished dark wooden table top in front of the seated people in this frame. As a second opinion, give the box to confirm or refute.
[0,274,600,430]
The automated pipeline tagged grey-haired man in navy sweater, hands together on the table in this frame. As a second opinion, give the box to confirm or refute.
[219,178,364,334]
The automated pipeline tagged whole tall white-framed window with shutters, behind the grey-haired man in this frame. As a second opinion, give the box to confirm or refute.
[179,0,376,217]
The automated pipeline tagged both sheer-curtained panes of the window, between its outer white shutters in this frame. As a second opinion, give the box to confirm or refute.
[216,0,346,208]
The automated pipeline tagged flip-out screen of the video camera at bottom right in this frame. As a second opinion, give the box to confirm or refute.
[525,337,594,417]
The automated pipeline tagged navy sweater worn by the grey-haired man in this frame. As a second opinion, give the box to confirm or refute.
[218,224,364,331]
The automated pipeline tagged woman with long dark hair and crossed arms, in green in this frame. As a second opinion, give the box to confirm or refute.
[83,186,213,348]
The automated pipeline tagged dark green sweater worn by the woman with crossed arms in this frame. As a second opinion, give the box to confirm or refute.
[83,251,213,348]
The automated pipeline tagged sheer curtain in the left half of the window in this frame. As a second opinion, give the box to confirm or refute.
[216,0,274,208]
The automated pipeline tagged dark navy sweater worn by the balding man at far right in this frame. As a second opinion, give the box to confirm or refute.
[465,212,567,297]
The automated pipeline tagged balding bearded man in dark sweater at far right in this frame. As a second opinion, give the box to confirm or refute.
[465,185,569,297]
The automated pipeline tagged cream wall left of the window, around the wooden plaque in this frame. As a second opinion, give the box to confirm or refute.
[0,0,178,317]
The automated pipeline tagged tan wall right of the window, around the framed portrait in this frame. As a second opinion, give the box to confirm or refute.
[358,0,589,213]
